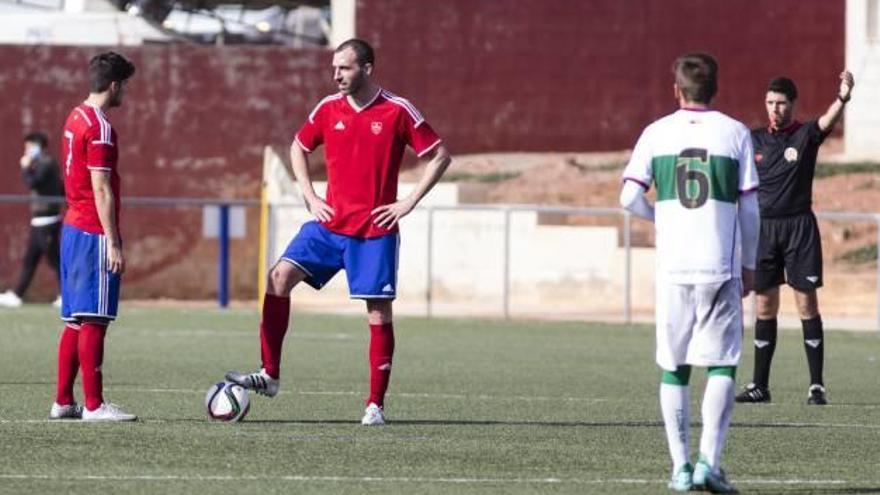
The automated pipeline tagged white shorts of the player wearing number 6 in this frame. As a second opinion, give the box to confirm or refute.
[657,278,743,371]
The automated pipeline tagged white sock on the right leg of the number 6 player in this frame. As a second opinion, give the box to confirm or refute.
[700,376,734,472]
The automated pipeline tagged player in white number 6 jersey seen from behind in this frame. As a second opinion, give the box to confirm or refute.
[620,53,759,493]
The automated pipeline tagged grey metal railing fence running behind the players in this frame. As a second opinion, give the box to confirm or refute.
[0,195,880,329]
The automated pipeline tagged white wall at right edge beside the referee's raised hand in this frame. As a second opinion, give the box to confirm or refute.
[844,0,880,160]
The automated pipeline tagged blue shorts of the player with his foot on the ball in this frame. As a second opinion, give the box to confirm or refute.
[281,220,400,299]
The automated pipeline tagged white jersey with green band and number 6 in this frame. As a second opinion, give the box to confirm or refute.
[623,109,758,284]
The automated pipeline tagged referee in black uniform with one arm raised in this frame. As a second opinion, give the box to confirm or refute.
[736,71,855,405]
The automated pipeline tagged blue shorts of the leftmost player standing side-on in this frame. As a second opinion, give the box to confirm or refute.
[61,224,120,321]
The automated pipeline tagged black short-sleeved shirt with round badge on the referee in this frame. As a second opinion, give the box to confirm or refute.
[752,120,828,218]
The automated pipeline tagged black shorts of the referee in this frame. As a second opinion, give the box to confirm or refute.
[755,212,822,291]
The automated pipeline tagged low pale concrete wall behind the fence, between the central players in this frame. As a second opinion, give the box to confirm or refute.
[268,183,654,319]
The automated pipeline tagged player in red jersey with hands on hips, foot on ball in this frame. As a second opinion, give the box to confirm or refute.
[226,39,451,425]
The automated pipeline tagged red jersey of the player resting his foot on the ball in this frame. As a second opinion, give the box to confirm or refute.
[295,90,440,238]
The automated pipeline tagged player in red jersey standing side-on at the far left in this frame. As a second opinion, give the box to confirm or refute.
[49,52,137,421]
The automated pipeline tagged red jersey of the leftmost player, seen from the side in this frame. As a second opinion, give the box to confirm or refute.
[61,103,120,234]
